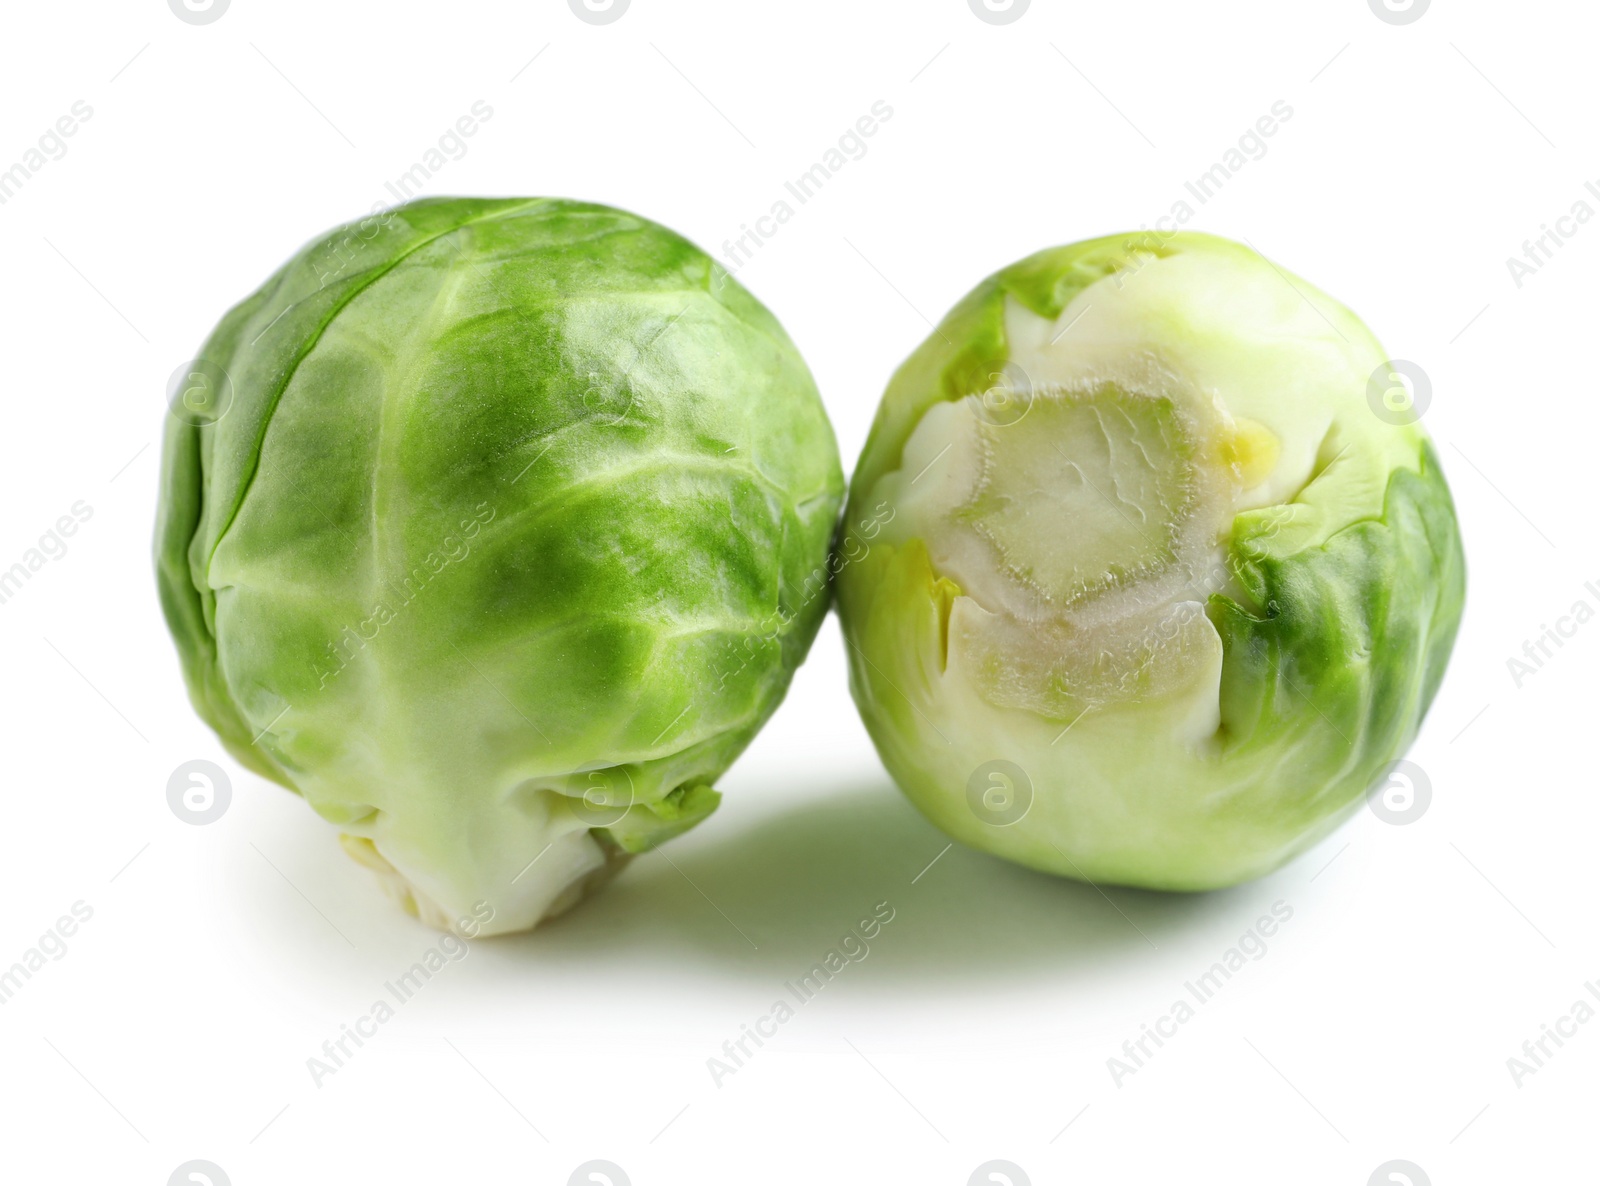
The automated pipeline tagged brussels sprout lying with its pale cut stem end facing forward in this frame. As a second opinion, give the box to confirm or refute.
[835,234,1464,890]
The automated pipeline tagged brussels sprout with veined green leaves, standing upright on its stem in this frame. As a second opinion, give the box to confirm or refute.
[155,198,843,933]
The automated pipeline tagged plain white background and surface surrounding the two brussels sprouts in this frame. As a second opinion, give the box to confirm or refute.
[0,0,1600,1186]
